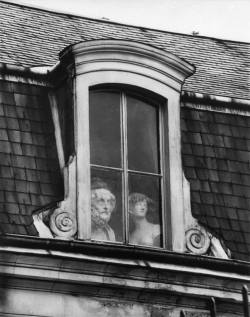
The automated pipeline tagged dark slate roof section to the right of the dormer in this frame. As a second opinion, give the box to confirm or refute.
[181,108,250,261]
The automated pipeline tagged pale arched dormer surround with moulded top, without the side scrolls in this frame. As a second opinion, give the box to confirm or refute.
[60,40,194,252]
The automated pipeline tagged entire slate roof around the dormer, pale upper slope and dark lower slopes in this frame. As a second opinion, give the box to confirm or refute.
[0,1,250,261]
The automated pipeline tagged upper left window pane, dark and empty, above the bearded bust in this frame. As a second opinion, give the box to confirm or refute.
[89,92,121,167]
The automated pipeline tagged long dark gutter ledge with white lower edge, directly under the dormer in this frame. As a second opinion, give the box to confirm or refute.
[0,234,250,279]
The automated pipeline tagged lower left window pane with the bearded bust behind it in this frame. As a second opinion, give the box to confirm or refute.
[91,168,124,242]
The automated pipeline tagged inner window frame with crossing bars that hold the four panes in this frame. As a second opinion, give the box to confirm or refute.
[89,85,169,249]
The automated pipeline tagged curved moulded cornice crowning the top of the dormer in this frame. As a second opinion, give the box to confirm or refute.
[59,40,195,83]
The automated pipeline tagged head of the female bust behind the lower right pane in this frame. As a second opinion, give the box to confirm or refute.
[128,193,154,218]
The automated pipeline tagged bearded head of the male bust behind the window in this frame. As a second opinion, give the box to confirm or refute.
[91,178,116,227]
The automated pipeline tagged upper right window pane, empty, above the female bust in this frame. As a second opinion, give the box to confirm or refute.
[127,96,159,173]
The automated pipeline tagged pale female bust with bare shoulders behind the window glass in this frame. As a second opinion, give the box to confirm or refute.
[129,193,161,247]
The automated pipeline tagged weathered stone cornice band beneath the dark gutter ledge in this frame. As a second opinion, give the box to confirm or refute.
[0,243,250,303]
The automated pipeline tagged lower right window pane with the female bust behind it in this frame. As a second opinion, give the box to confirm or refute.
[128,173,162,247]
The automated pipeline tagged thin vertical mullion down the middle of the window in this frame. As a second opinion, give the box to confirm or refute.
[121,92,128,244]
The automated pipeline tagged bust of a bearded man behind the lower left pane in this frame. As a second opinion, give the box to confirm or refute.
[91,178,116,241]
